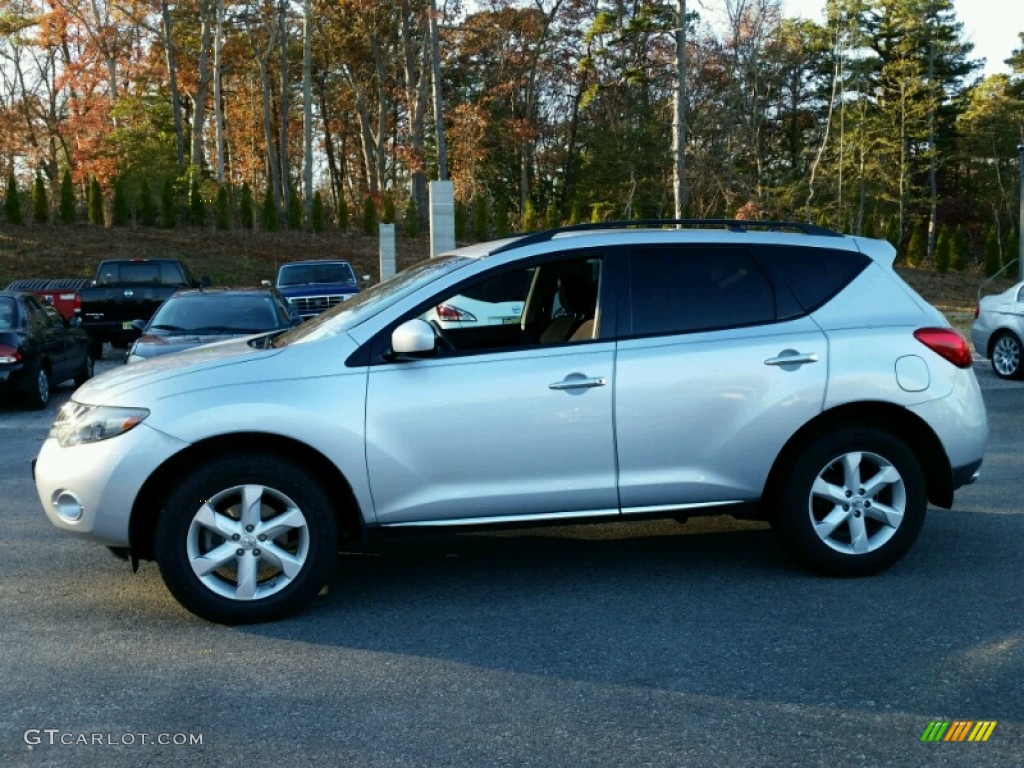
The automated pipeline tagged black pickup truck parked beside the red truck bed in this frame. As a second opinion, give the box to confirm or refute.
[79,259,203,359]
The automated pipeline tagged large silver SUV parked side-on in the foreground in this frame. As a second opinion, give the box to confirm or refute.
[34,221,988,623]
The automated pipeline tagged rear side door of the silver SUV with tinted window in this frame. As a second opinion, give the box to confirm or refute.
[615,246,828,514]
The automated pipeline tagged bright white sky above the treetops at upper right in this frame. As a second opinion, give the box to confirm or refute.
[778,0,1024,75]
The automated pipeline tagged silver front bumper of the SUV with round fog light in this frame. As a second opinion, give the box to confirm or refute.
[32,423,187,547]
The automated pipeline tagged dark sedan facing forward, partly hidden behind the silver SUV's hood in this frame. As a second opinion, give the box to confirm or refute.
[125,288,302,362]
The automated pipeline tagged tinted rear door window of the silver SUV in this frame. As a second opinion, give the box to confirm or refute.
[630,248,776,335]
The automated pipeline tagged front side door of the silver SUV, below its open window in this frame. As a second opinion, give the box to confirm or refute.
[366,259,618,525]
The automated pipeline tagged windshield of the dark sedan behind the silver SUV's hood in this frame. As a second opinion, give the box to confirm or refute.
[146,293,283,335]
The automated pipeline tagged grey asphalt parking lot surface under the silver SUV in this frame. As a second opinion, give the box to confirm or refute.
[0,356,1024,768]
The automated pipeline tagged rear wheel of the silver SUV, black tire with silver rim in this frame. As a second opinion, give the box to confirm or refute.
[771,426,928,577]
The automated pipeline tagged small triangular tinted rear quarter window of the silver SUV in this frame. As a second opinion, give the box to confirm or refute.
[763,248,870,312]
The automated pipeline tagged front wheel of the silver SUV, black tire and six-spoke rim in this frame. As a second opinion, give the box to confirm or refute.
[155,454,339,624]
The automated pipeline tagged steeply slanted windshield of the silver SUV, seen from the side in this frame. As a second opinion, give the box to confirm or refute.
[272,256,476,347]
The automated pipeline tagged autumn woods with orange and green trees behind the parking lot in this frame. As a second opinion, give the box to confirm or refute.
[0,0,1024,271]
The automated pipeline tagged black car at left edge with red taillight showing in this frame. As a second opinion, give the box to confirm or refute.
[0,291,92,409]
